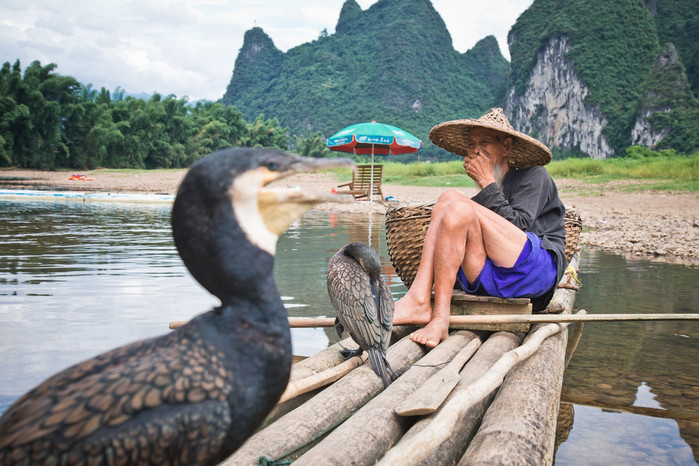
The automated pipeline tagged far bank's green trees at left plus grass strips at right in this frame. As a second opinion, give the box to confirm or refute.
[0,60,697,174]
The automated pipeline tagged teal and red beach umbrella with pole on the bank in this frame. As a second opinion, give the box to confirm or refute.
[328,121,422,201]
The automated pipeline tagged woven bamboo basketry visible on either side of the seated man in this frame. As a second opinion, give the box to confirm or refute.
[386,202,582,288]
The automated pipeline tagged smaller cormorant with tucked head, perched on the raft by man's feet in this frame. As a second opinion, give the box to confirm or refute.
[327,242,393,387]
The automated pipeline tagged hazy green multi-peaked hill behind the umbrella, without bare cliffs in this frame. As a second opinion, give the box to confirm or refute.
[222,0,509,157]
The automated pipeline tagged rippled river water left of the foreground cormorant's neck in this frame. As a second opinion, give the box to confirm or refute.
[0,202,215,402]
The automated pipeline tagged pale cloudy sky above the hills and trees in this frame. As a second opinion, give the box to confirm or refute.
[0,0,533,100]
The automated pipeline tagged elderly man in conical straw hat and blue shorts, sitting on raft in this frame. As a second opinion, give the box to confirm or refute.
[393,108,567,347]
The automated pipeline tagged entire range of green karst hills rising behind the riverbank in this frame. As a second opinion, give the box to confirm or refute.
[222,0,699,158]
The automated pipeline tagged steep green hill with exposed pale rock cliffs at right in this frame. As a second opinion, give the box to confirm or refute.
[504,0,699,158]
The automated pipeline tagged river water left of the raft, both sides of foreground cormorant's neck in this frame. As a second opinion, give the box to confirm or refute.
[0,201,405,402]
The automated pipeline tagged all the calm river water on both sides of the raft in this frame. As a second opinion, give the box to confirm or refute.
[0,201,699,465]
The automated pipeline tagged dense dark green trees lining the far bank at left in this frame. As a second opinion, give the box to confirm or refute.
[0,60,289,170]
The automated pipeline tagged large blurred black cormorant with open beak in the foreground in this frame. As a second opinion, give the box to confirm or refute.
[0,148,351,465]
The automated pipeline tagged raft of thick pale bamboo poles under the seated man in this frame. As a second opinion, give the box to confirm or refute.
[217,206,584,465]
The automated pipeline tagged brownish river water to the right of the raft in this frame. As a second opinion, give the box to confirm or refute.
[556,251,699,464]
